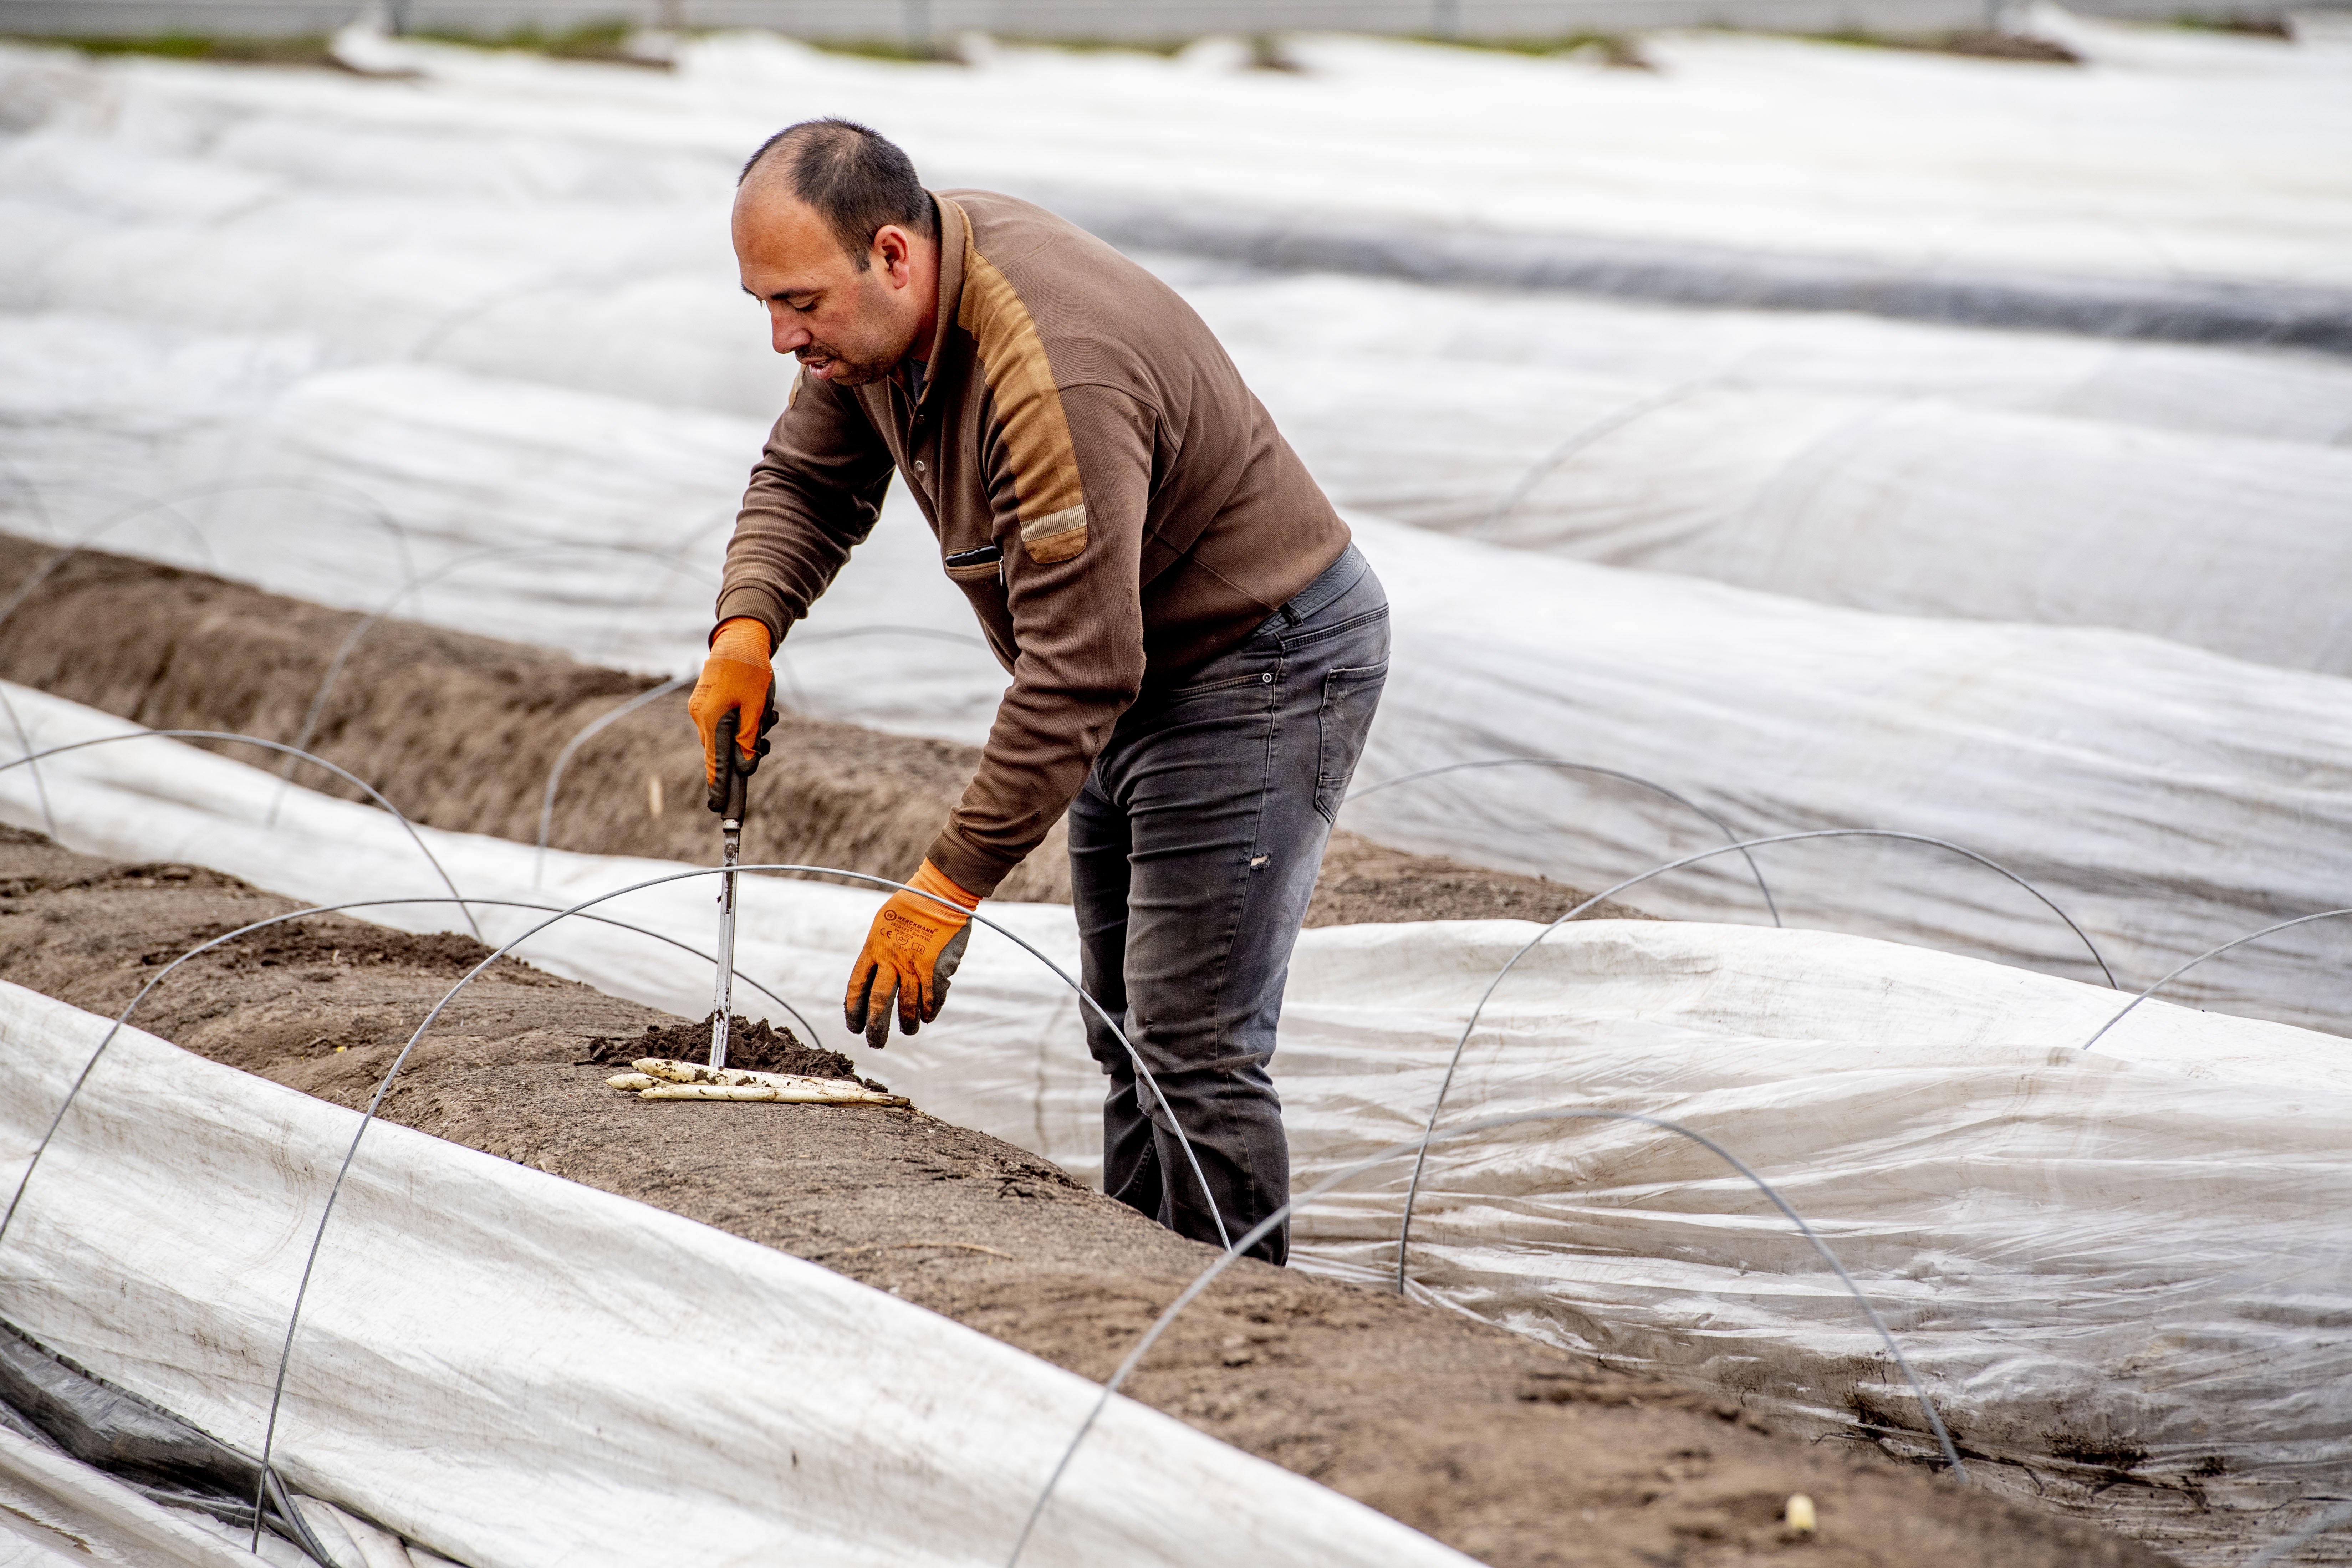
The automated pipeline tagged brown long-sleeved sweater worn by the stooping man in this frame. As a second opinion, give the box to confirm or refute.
[717,190,1348,893]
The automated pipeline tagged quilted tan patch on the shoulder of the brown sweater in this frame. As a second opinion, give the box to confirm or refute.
[955,228,1087,564]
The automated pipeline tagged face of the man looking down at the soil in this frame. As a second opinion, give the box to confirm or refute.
[734,187,929,385]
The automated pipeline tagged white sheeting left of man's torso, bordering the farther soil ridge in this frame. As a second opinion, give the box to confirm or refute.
[0,317,1004,741]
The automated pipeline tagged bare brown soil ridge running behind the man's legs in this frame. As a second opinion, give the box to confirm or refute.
[0,533,1647,926]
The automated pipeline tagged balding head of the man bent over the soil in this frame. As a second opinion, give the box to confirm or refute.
[734,120,938,385]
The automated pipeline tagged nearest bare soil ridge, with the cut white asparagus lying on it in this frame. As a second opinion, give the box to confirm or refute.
[0,830,2171,1568]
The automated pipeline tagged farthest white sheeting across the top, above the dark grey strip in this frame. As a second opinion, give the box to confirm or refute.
[18,13,2352,285]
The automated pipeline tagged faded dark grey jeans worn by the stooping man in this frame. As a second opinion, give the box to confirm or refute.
[1070,545,1388,1262]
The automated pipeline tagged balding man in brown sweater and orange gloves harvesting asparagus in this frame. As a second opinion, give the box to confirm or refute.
[692,120,1388,1262]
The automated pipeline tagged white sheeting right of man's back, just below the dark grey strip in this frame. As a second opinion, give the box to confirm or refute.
[1242,348,2352,675]
